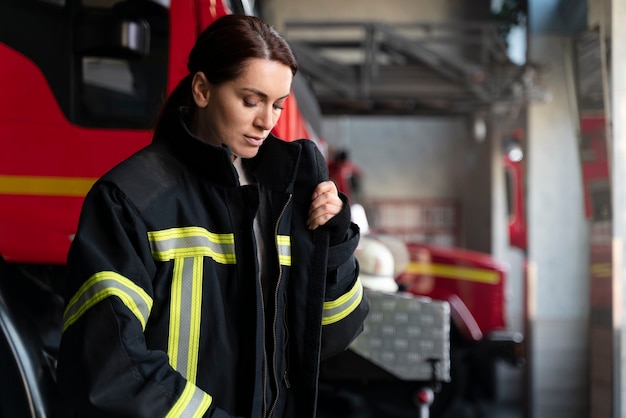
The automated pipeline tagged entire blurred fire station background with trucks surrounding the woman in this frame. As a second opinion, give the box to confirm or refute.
[0,0,626,418]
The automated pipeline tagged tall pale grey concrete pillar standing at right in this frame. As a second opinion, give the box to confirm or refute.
[528,35,589,418]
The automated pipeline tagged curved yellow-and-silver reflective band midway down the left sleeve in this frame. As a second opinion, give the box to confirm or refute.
[63,271,152,331]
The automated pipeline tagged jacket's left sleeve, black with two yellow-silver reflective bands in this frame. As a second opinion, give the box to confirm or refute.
[57,183,241,418]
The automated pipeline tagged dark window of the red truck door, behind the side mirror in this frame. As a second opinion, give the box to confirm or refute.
[75,0,169,129]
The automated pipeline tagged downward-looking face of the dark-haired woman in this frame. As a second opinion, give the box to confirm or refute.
[191,58,293,158]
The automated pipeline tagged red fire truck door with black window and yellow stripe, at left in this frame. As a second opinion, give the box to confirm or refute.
[0,0,170,264]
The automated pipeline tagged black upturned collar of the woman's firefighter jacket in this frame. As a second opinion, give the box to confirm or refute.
[154,107,301,192]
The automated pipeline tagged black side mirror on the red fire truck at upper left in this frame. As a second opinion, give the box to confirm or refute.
[74,14,150,59]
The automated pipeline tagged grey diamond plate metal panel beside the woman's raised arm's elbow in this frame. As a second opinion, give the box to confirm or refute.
[350,289,450,382]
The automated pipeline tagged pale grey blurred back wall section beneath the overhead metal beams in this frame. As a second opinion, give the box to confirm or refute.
[324,116,467,199]
